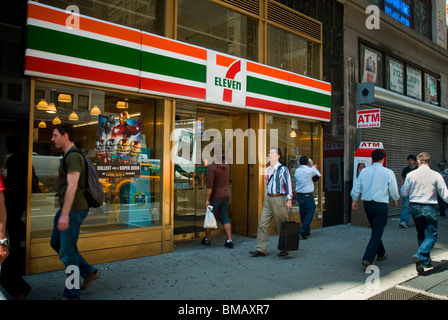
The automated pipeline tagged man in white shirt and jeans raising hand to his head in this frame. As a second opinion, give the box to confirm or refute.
[294,156,321,239]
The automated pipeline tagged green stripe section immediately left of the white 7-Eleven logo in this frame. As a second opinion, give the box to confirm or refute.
[142,51,207,83]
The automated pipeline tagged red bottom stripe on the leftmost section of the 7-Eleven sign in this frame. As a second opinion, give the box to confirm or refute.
[25,56,139,88]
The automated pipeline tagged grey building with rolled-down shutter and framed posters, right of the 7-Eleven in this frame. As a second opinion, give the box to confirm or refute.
[344,0,448,221]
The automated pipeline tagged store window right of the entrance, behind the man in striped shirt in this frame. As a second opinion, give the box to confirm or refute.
[266,115,322,214]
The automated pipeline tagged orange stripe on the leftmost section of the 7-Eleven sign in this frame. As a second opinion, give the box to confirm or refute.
[28,3,141,43]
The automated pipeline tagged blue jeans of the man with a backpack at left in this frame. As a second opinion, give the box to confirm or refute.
[50,210,94,299]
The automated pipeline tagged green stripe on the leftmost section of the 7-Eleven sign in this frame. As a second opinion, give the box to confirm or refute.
[27,25,140,70]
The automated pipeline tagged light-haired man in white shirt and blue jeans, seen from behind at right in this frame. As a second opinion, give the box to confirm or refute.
[401,152,448,274]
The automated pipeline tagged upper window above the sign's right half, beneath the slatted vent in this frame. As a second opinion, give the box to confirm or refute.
[267,25,320,78]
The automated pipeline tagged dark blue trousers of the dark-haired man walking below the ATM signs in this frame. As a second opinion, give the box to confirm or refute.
[362,201,388,263]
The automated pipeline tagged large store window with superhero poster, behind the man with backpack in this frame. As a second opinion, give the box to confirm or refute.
[31,81,163,238]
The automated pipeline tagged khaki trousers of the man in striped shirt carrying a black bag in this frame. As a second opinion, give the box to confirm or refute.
[257,196,288,254]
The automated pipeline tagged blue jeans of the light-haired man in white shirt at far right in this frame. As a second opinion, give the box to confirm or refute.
[410,203,438,267]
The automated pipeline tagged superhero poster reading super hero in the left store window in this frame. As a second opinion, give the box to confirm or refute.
[95,112,143,178]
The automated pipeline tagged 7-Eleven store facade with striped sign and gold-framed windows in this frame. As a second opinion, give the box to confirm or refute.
[0,0,333,273]
